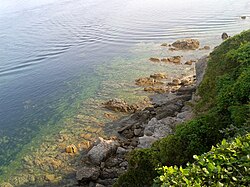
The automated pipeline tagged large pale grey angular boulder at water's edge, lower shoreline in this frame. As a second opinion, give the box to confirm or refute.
[87,138,119,165]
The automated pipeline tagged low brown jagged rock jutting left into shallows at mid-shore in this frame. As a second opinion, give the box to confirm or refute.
[104,98,138,113]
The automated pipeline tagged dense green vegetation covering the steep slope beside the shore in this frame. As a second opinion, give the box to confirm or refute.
[114,30,250,187]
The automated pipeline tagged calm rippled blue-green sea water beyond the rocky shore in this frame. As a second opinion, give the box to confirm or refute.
[0,0,250,185]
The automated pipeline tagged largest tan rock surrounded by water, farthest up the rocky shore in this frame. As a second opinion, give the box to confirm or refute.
[172,39,200,50]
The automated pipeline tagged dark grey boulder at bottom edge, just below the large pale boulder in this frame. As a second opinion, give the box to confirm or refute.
[76,166,100,182]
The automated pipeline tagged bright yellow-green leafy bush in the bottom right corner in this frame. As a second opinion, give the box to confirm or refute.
[153,134,250,187]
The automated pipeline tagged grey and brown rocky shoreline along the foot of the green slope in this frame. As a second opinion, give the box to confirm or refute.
[76,49,207,187]
